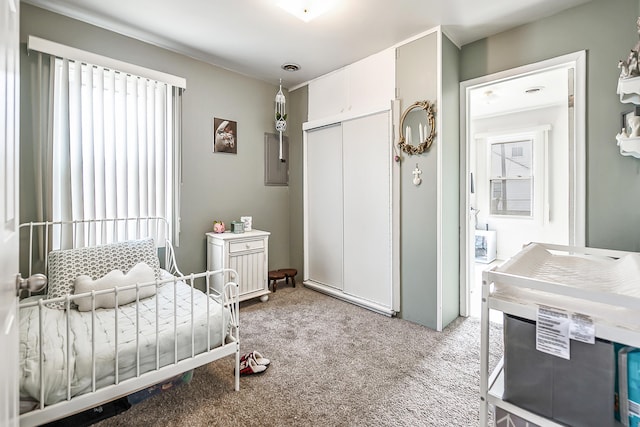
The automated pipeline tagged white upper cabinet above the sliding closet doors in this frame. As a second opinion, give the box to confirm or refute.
[309,49,395,121]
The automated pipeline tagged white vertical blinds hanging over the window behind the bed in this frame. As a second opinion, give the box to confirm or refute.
[36,58,182,249]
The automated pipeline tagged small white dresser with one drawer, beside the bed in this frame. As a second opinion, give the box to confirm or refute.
[207,230,271,301]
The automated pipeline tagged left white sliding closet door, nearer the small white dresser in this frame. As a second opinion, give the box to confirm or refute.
[305,124,343,289]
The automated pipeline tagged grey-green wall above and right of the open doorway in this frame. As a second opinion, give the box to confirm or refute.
[461,0,640,251]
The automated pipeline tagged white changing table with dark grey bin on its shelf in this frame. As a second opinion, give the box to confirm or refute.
[480,244,640,427]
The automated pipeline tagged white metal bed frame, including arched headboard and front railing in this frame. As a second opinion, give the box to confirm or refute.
[20,217,240,426]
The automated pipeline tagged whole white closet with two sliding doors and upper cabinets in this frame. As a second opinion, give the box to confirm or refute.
[303,49,399,315]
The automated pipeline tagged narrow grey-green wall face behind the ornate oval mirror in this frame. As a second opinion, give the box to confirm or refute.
[396,33,441,328]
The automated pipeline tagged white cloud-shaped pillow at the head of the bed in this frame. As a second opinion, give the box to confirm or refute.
[74,262,156,311]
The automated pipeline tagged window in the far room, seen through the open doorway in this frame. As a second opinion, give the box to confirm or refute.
[490,139,533,216]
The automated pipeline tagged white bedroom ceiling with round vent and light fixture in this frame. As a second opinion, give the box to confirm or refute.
[23,0,591,88]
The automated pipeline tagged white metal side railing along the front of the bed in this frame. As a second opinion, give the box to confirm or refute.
[20,269,240,426]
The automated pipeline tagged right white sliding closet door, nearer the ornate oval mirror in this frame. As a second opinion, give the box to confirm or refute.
[342,112,392,308]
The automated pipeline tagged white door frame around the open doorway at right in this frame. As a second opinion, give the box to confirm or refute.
[460,50,587,317]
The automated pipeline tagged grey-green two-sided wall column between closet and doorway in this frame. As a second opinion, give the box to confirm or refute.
[396,32,460,329]
